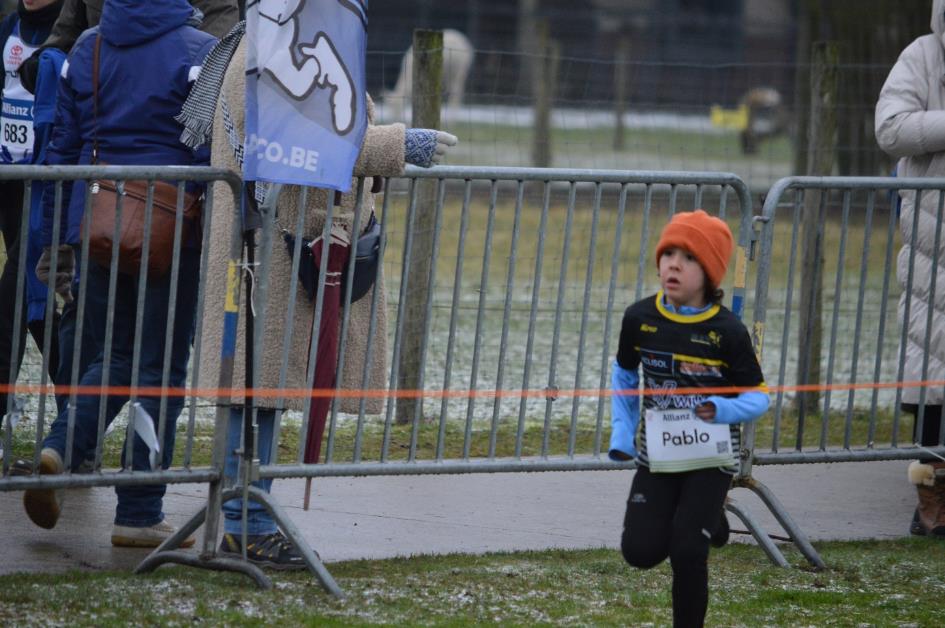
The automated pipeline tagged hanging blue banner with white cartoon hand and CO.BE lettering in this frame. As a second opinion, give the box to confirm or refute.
[243,0,367,192]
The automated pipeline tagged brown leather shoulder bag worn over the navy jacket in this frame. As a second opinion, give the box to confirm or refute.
[83,35,202,278]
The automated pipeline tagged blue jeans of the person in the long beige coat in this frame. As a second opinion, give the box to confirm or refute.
[223,406,277,535]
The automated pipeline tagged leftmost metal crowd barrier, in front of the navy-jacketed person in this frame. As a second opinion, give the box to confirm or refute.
[0,166,296,593]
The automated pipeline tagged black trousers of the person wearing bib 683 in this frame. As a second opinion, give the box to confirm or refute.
[0,181,59,422]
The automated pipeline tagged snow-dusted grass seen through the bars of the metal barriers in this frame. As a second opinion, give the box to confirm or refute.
[0,172,911,460]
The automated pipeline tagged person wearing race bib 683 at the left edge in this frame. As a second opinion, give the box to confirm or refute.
[0,0,62,442]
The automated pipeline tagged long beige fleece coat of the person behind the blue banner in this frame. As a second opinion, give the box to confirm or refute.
[200,39,406,414]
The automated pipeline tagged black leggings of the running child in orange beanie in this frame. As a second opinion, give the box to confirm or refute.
[620,466,732,628]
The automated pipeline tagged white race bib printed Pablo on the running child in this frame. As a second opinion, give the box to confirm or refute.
[645,409,736,473]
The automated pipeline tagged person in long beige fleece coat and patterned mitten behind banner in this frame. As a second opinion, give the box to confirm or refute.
[200,39,456,569]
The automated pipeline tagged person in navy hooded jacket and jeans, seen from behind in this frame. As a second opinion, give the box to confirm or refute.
[24,0,216,547]
